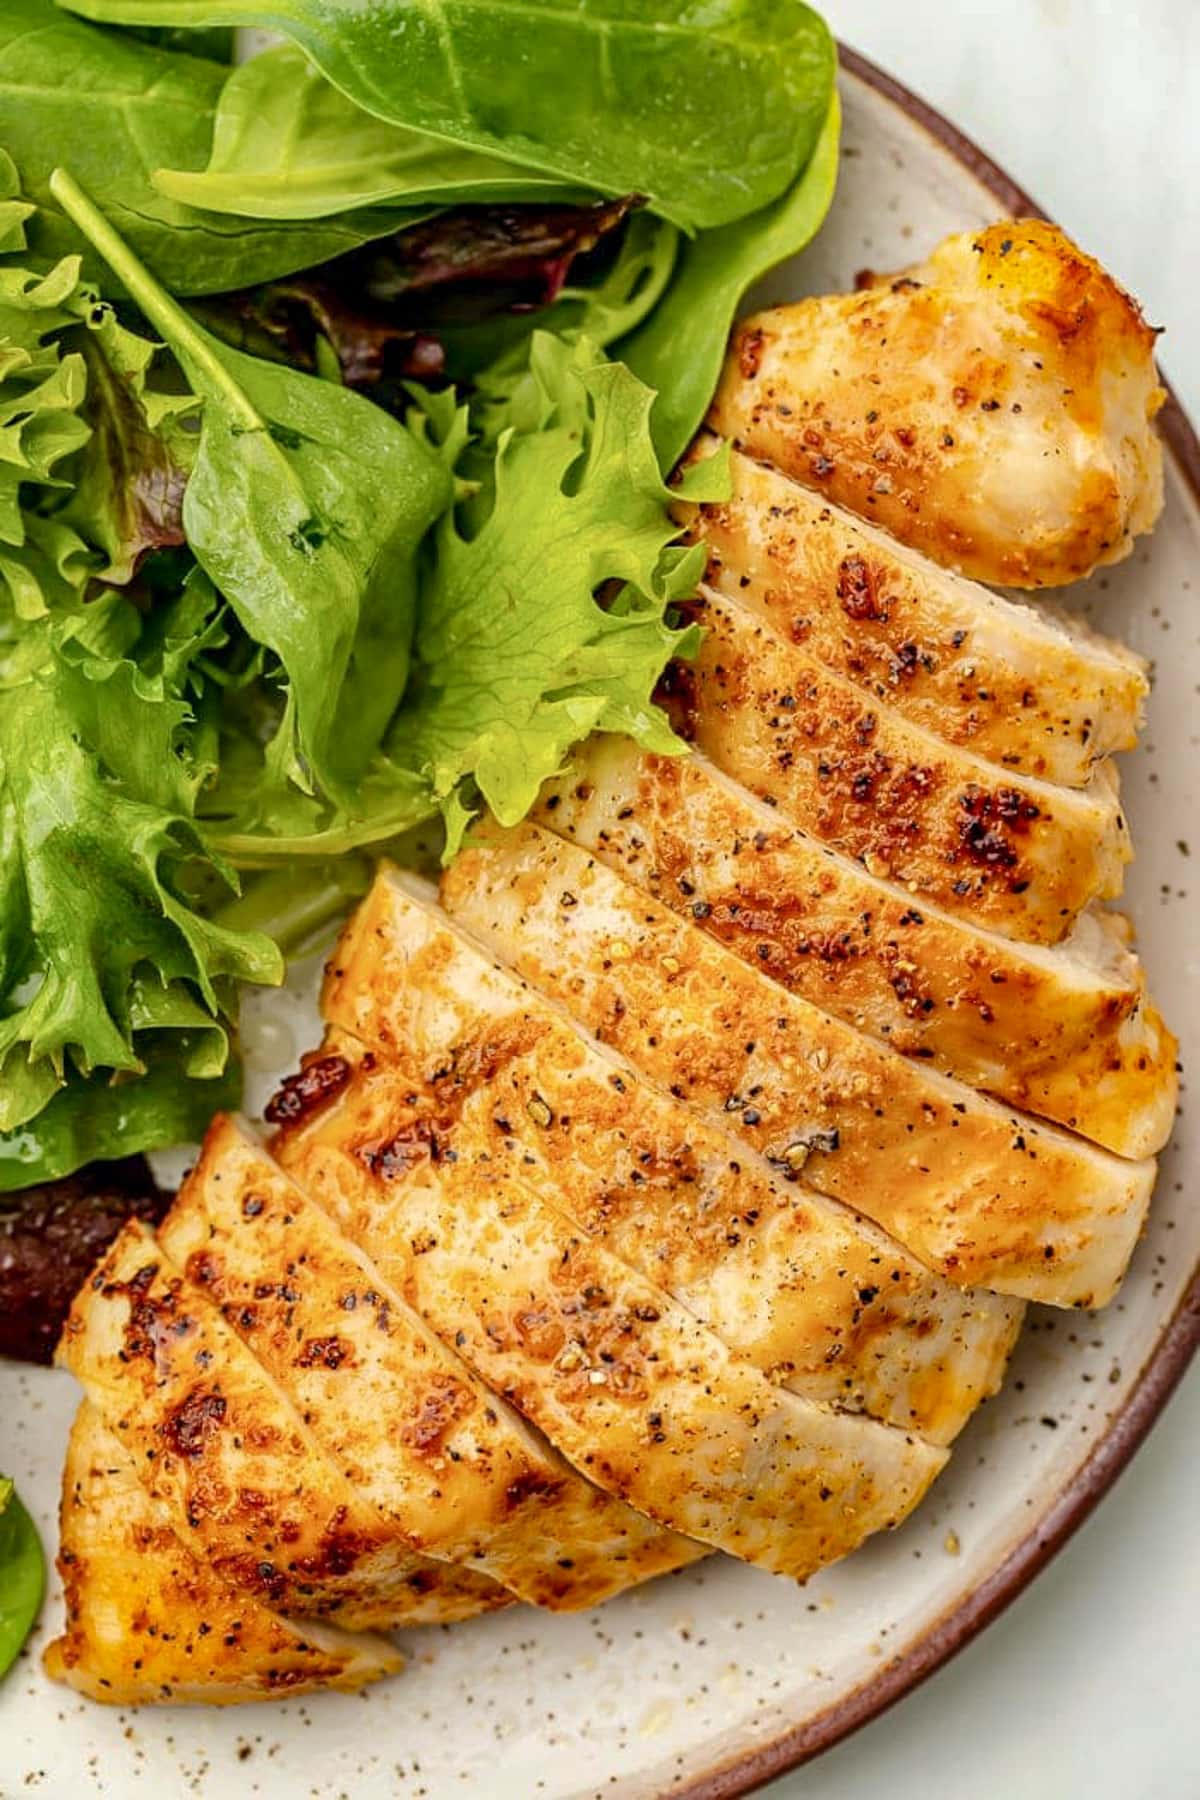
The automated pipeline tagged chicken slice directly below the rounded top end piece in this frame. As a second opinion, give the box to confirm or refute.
[676,434,1148,787]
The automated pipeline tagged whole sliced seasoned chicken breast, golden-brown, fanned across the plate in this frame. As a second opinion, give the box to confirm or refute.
[39,210,1177,1703]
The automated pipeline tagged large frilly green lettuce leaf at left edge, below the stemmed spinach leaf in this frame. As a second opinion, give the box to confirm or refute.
[0,590,282,1132]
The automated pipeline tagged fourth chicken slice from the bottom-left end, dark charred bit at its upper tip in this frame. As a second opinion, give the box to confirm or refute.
[277,1101,946,1579]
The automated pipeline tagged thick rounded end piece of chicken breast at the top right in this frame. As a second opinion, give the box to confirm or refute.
[709,220,1164,587]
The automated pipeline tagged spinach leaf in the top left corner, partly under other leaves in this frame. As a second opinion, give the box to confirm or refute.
[0,0,422,293]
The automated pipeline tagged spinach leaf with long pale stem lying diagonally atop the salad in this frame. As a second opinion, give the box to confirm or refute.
[50,169,452,801]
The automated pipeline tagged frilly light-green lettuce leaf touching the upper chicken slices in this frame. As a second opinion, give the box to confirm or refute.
[385,333,703,851]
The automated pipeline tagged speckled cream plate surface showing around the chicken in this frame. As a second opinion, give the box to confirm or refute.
[0,49,1200,1800]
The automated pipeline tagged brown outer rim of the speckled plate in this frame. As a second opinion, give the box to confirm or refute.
[671,45,1200,1800]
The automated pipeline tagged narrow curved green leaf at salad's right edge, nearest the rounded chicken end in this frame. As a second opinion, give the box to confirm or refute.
[613,94,840,468]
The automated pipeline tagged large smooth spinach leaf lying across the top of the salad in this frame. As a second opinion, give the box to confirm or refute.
[68,0,835,230]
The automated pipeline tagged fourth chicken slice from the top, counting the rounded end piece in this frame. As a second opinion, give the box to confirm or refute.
[536,736,1178,1157]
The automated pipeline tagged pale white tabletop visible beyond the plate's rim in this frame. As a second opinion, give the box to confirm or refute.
[770,0,1200,1800]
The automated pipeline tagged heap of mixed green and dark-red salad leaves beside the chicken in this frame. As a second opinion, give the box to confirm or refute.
[0,0,838,1195]
